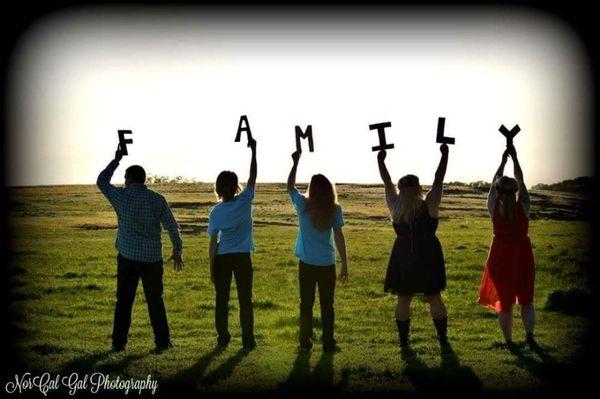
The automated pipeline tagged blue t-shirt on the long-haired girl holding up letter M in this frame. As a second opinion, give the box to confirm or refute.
[290,188,344,266]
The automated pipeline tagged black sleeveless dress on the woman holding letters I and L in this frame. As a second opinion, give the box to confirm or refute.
[383,202,446,295]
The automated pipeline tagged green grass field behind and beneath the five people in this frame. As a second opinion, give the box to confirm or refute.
[4,184,591,392]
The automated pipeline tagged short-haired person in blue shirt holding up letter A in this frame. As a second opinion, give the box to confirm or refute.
[208,139,257,350]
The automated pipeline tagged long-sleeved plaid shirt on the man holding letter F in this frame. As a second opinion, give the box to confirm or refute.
[96,160,183,262]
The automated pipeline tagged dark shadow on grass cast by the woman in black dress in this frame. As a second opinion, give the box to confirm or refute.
[401,348,482,393]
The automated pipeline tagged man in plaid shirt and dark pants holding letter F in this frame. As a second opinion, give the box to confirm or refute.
[97,147,184,351]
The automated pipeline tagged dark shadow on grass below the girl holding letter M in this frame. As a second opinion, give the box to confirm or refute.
[279,352,342,393]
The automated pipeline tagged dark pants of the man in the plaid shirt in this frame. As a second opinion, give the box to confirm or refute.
[112,254,169,348]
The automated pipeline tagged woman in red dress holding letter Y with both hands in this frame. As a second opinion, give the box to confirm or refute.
[477,145,535,344]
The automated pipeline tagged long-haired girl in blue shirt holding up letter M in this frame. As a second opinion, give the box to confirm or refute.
[287,151,348,352]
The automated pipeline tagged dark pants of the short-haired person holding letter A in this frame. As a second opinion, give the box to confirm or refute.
[213,252,254,345]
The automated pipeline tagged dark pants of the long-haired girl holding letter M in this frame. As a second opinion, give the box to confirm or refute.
[299,261,335,348]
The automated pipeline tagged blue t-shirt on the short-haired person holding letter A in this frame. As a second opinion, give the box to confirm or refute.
[207,186,254,255]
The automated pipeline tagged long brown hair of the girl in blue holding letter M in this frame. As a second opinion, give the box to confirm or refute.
[306,174,337,231]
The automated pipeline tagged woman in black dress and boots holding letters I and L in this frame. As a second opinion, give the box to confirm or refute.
[377,144,451,352]
